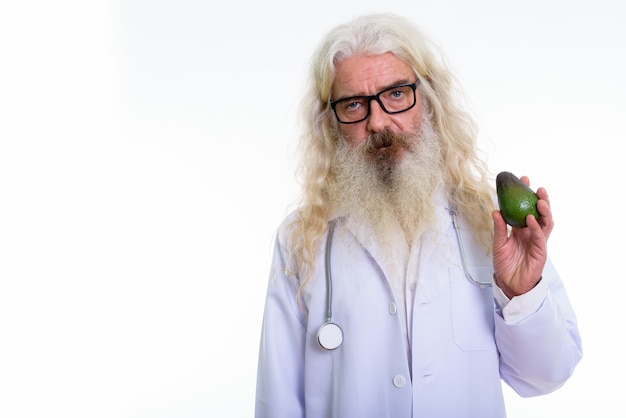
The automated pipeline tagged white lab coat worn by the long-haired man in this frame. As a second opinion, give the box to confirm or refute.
[256,200,582,418]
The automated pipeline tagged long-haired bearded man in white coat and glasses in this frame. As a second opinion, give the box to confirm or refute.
[256,15,582,418]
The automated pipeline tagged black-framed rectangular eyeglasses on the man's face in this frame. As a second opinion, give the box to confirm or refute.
[330,79,420,124]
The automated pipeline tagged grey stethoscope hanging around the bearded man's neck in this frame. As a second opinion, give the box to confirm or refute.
[317,205,492,350]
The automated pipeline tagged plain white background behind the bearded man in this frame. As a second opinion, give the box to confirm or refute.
[0,0,626,418]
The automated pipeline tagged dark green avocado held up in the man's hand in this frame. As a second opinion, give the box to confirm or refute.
[496,171,539,228]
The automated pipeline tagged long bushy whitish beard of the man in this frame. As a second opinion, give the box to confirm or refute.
[331,115,443,248]
